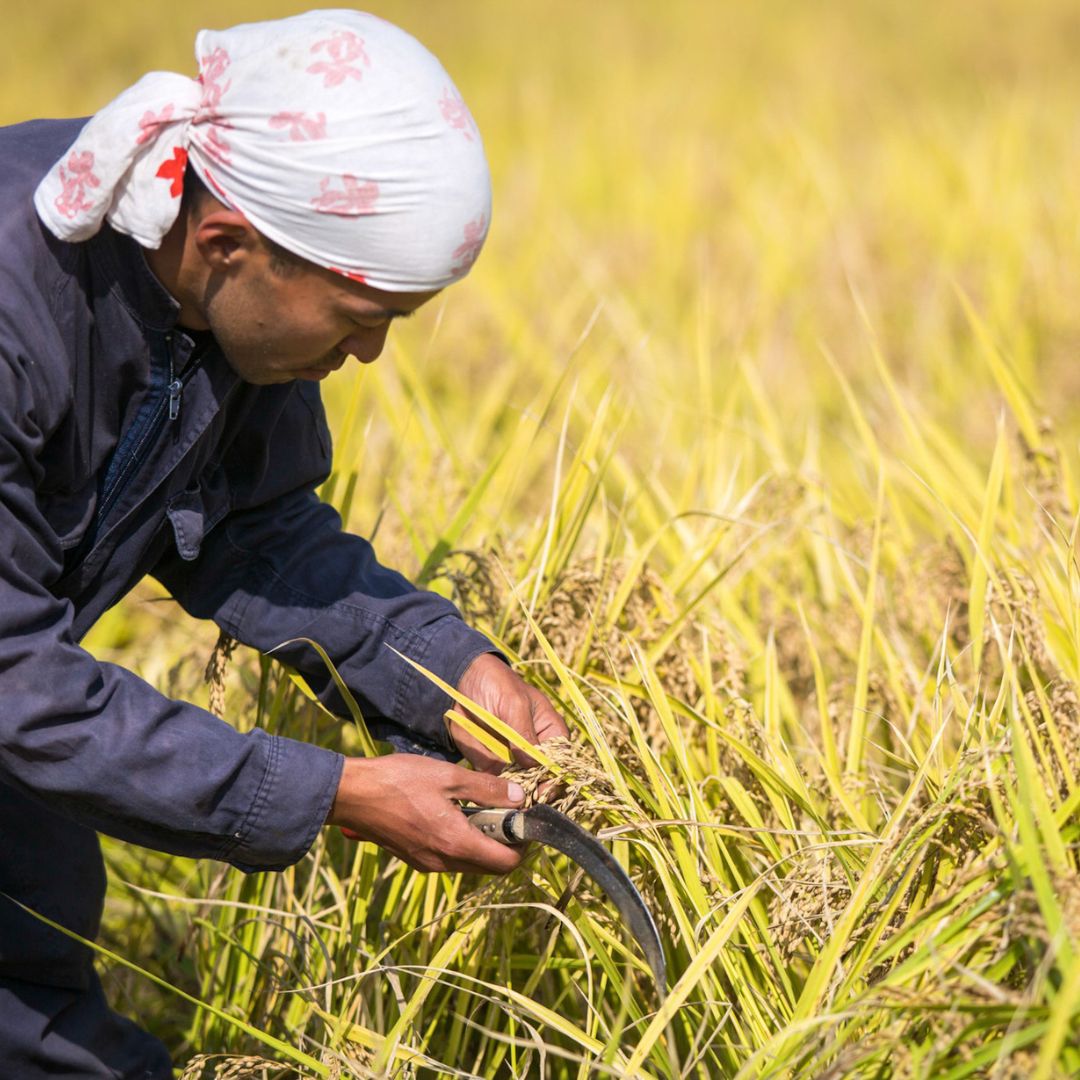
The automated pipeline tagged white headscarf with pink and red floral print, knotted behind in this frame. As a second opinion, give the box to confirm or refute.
[33,11,491,292]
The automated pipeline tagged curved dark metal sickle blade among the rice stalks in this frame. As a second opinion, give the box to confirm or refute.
[512,804,667,998]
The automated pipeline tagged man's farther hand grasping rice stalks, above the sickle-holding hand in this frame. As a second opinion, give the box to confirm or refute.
[450,652,569,773]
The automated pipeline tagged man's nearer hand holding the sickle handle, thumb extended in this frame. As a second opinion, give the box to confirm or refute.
[326,754,525,874]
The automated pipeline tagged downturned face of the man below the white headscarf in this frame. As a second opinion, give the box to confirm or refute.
[202,244,436,386]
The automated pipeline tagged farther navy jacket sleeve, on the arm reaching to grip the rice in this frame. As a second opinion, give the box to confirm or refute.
[154,383,497,757]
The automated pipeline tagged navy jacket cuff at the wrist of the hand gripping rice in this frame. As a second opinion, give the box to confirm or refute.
[391,616,505,758]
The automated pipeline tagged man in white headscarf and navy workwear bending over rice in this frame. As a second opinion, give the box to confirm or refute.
[0,11,566,1080]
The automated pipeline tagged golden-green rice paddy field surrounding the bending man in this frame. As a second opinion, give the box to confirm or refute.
[6,0,1080,1080]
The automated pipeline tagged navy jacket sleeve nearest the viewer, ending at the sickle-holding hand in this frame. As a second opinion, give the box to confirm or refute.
[0,317,341,869]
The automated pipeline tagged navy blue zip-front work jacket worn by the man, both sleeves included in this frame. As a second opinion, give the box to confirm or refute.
[0,121,492,876]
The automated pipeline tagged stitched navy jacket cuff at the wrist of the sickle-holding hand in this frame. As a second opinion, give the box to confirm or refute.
[227,735,345,874]
